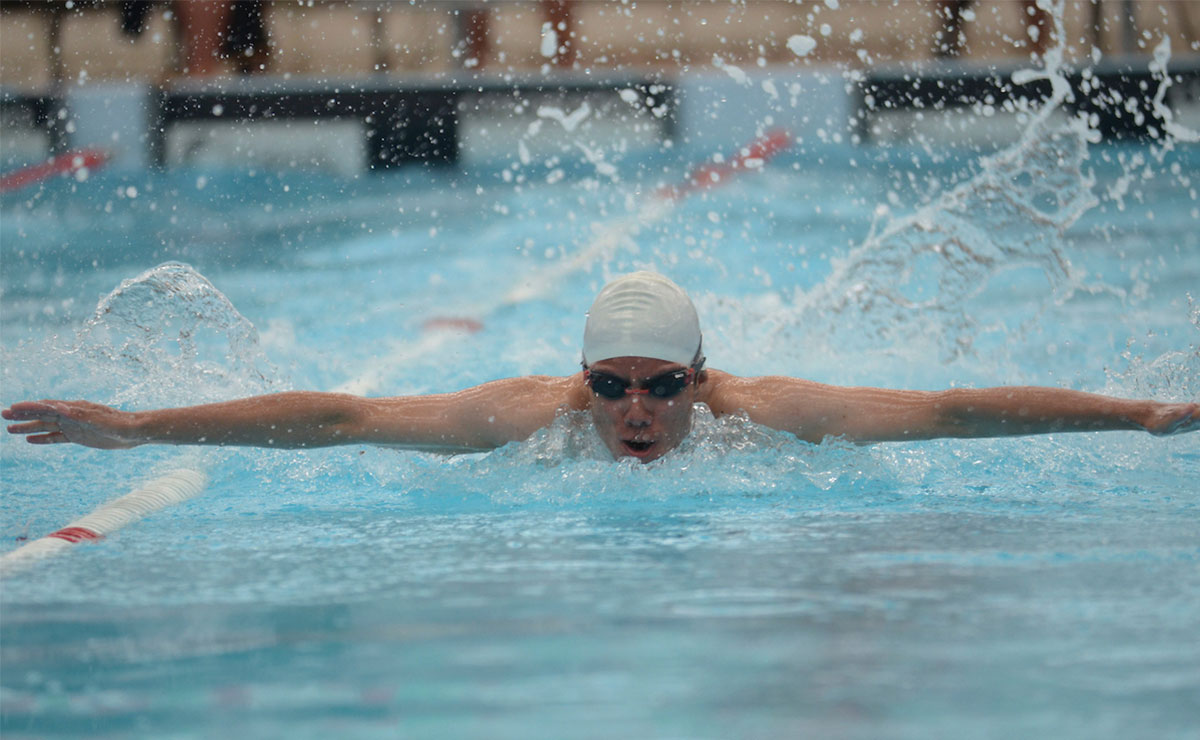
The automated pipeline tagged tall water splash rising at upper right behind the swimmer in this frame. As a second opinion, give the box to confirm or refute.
[784,4,1098,362]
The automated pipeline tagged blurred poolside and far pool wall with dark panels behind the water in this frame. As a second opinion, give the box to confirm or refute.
[0,0,1200,178]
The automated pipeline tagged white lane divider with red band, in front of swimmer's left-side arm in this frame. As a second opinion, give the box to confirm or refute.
[0,469,208,578]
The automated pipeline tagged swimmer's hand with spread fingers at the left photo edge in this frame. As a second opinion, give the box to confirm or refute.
[0,401,140,450]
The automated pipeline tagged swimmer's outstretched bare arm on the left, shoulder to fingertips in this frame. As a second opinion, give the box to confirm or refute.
[2,377,578,452]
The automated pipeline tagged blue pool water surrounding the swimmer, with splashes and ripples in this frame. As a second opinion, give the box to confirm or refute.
[0,100,1200,738]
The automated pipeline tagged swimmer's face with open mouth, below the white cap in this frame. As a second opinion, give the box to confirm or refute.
[588,357,704,463]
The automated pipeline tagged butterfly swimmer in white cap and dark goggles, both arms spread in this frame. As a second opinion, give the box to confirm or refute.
[2,272,1200,462]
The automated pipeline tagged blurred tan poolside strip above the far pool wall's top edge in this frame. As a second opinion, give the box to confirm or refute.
[0,0,1200,89]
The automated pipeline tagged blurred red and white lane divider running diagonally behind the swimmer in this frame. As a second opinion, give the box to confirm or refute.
[334,128,793,396]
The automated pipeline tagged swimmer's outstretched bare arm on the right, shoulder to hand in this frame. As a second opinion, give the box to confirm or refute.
[710,374,1200,443]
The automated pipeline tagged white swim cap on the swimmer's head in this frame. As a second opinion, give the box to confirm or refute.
[583,272,701,367]
